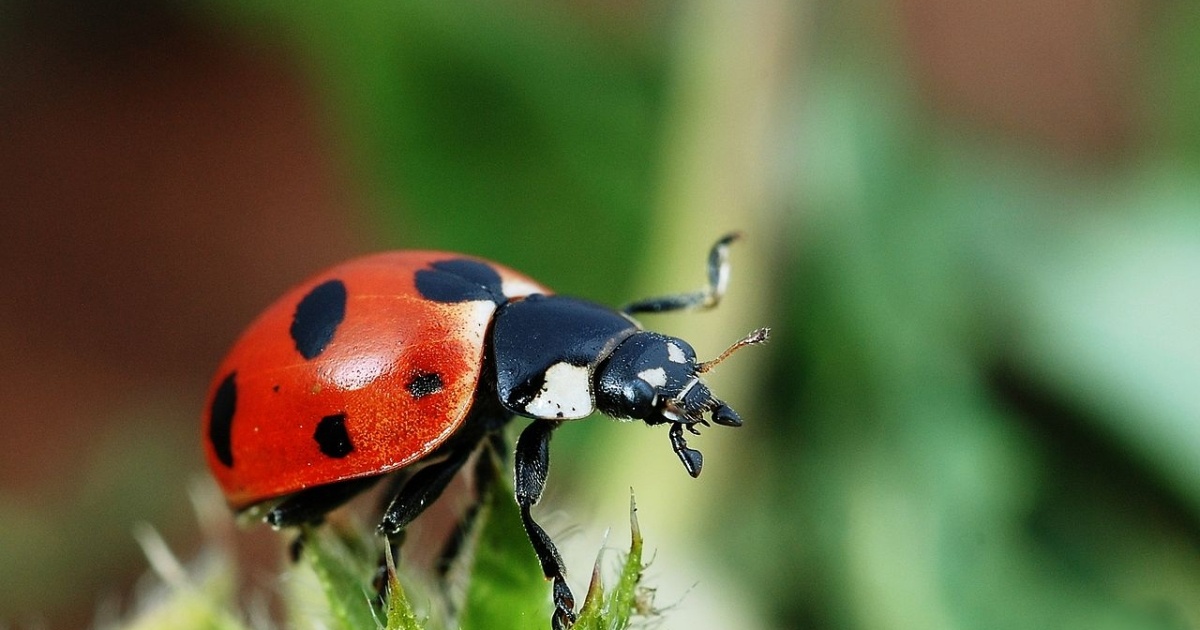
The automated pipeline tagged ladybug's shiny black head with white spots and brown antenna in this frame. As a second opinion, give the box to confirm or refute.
[595,329,768,427]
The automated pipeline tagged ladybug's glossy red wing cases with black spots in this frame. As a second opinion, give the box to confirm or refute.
[204,251,551,509]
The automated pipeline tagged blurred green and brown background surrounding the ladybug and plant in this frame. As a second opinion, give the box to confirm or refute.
[0,0,1200,629]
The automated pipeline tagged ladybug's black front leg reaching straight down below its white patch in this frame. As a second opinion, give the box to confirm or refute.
[515,420,576,630]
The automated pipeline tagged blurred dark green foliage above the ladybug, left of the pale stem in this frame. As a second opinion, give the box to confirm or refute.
[202,0,666,300]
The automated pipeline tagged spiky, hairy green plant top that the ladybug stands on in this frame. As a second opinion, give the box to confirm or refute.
[112,480,658,630]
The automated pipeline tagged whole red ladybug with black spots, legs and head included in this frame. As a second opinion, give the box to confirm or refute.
[203,234,768,629]
